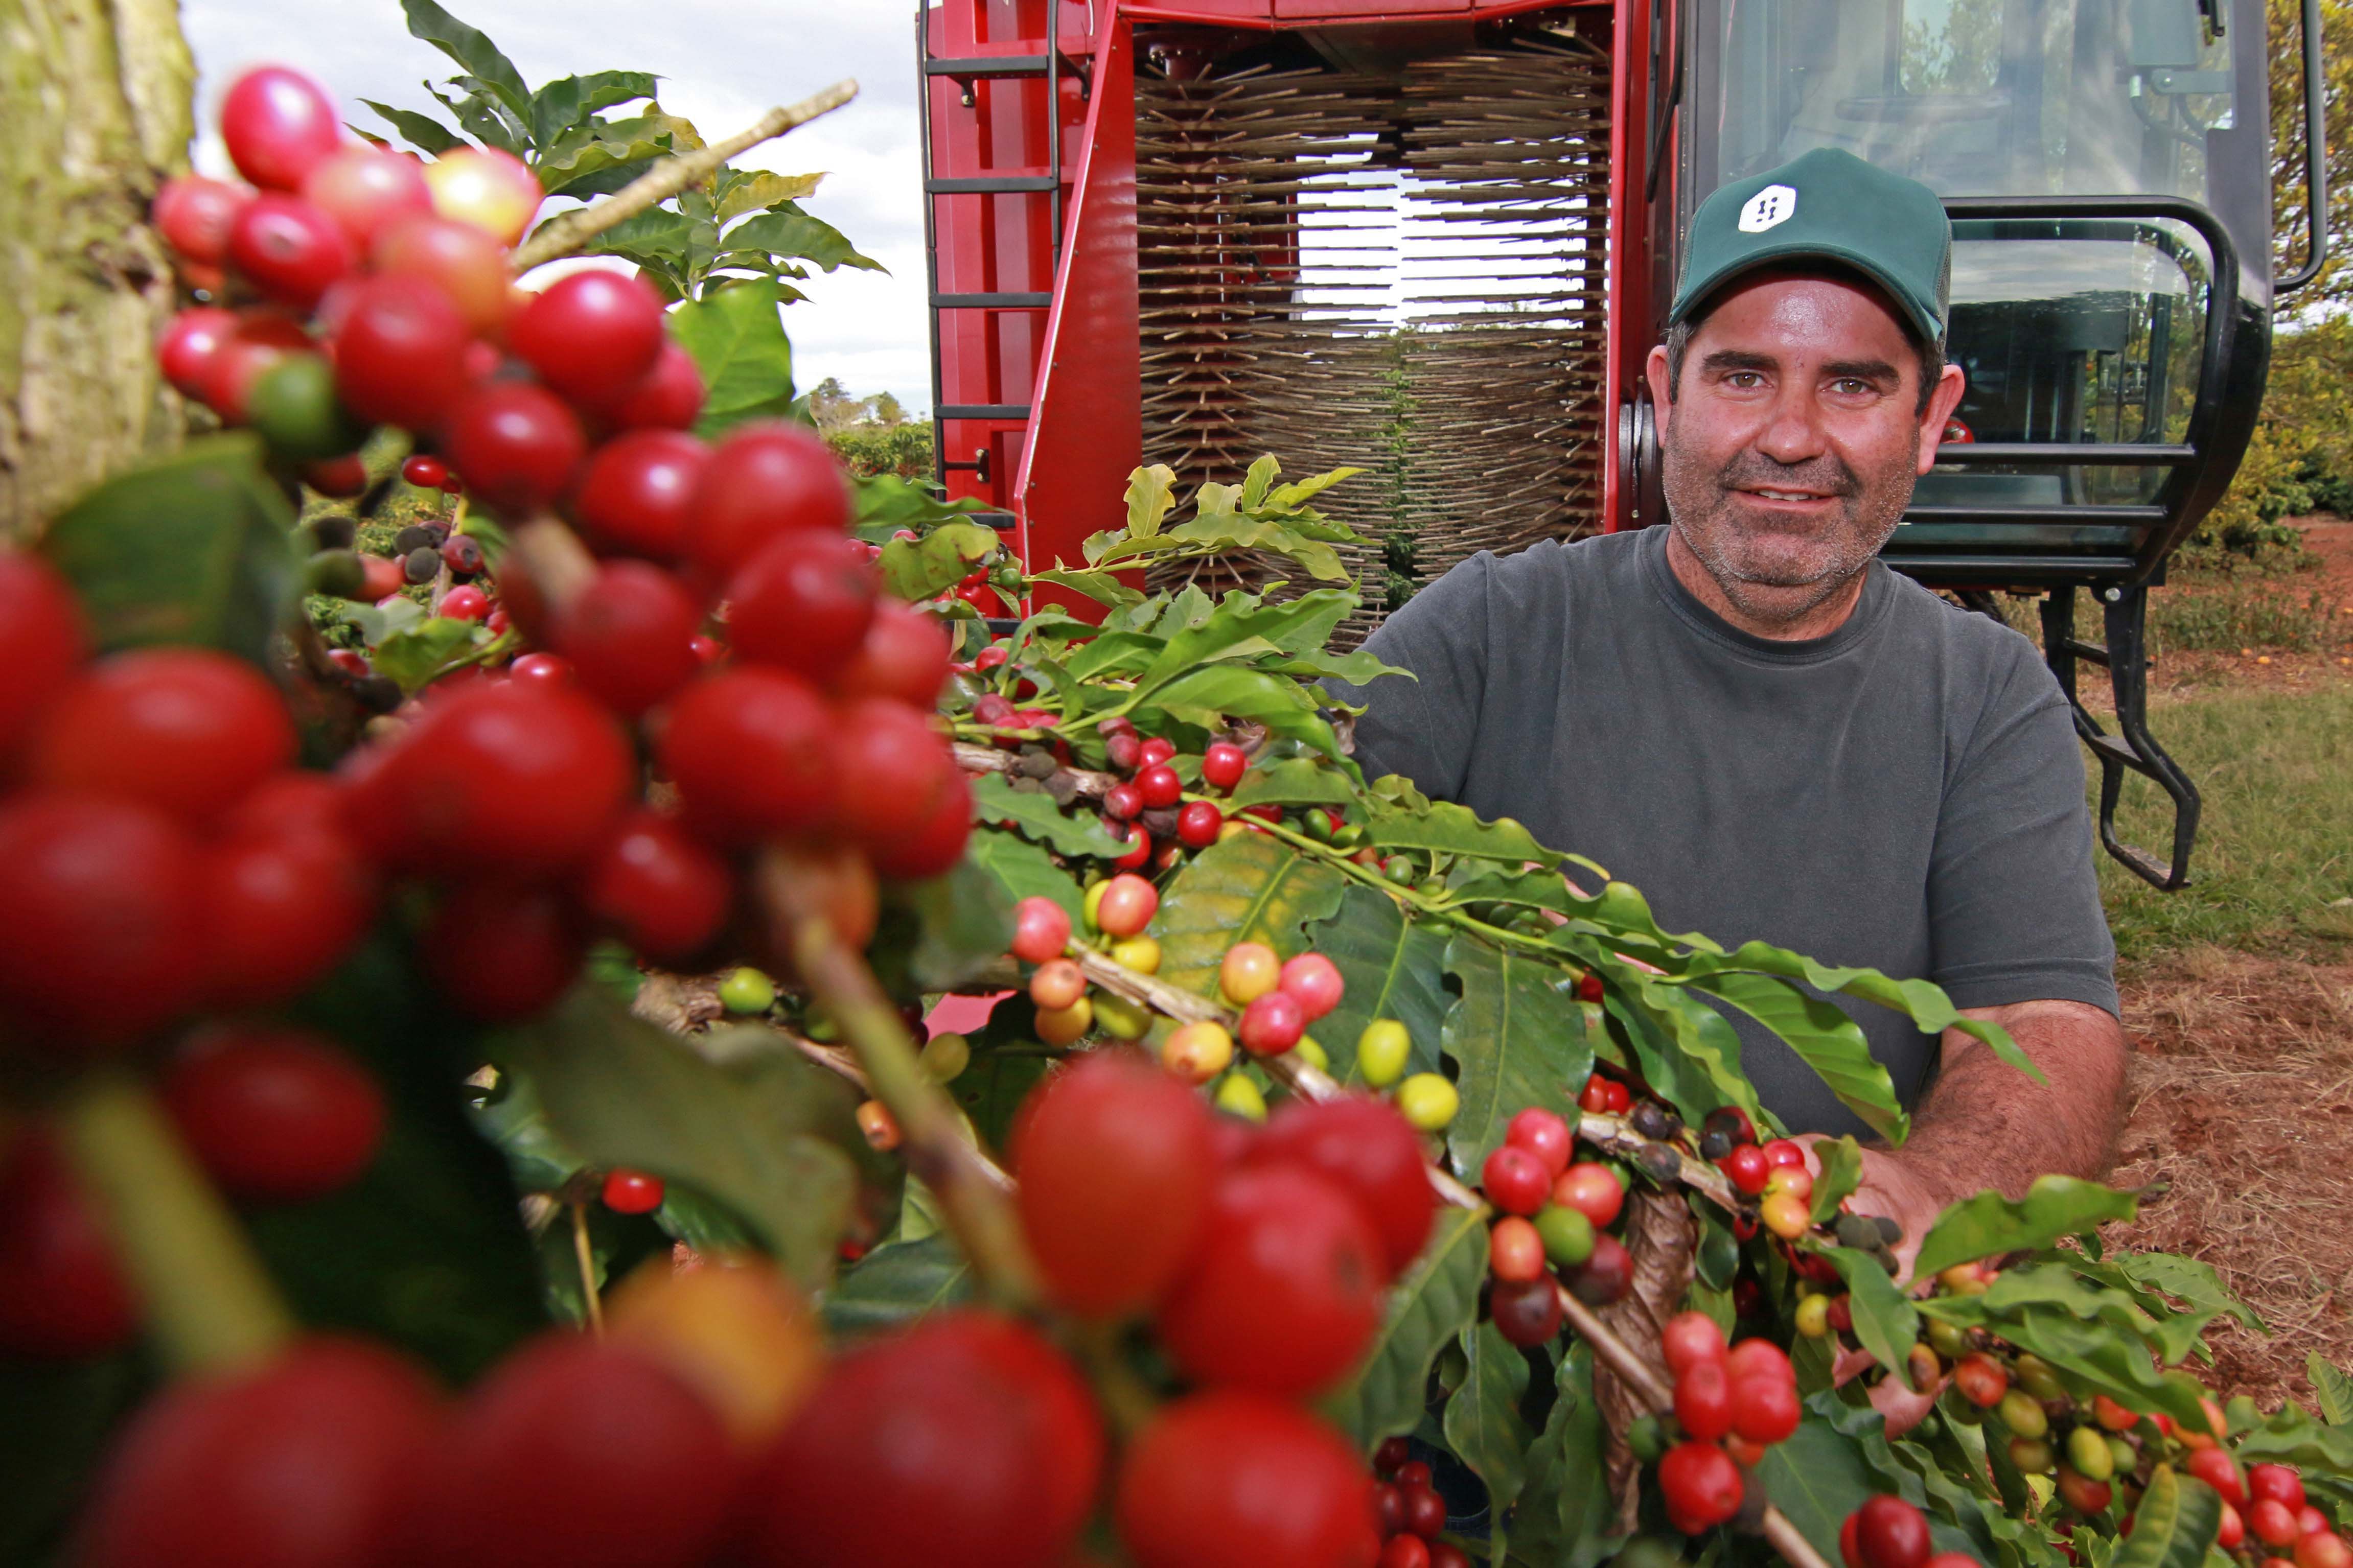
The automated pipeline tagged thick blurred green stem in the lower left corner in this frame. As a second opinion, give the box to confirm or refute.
[59,1070,294,1373]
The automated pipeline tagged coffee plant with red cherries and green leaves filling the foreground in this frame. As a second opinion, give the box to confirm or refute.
[0,36,2353,1568]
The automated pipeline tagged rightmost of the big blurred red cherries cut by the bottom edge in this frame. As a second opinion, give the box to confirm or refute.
[1113,1389,1374,1568]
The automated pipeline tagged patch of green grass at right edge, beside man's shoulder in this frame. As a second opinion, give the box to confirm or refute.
[2094,682,2353,962]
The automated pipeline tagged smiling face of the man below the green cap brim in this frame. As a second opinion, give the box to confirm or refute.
[1649,273,1960,623]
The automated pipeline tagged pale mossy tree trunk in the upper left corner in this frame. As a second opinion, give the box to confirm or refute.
[0,0,195,541]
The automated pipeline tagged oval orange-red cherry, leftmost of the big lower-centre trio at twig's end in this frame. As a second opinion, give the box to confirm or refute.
[1012,1048,1216,1317]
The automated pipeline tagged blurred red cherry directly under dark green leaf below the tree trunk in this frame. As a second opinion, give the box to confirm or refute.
[31,649,294,825]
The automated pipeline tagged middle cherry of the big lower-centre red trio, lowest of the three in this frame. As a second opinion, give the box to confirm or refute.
[1158,1164,1383,1396]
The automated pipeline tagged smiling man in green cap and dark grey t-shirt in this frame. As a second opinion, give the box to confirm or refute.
[1341,150,2125,1255]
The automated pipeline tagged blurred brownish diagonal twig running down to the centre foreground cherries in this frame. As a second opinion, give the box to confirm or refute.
[755,851,1035,1305]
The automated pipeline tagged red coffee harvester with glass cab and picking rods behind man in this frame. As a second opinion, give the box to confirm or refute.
[918,0,2327,888]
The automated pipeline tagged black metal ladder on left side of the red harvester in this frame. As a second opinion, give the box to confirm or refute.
[915,0,1090,529]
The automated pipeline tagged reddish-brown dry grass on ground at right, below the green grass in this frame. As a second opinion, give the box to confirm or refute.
[2108,947,2353,1411]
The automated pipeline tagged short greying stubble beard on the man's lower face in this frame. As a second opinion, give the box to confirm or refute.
[1659,426,1918,623]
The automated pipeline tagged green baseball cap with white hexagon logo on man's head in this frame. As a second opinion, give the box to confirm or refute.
[1666,148,1953,343]
